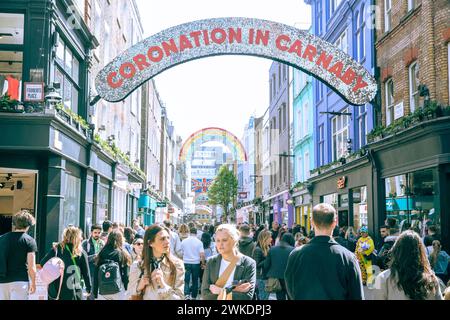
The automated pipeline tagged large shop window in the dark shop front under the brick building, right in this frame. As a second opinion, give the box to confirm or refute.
[385,169,441,236]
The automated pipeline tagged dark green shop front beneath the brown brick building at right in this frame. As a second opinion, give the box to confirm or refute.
[369,117,450,250]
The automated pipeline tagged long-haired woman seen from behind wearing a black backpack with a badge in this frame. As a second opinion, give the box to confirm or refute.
[94,230,131,300]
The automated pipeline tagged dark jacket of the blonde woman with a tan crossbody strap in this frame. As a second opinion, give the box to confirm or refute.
[202,254,256,300]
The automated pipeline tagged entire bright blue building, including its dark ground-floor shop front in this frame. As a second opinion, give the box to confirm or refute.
[305,0,377,230]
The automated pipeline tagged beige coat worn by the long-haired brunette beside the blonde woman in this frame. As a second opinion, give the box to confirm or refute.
[127,256,184,300]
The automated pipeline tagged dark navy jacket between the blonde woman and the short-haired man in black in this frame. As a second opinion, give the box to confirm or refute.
[264,241,294,279]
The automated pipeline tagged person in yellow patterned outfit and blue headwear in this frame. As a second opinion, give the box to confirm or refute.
[355,226,376,285]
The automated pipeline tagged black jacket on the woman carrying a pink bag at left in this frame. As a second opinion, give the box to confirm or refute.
[40,245,91,300]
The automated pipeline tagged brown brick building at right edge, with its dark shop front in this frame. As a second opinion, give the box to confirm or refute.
[369,0,450,250]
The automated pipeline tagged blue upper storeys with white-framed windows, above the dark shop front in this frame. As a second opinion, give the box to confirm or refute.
[305,0,375,167]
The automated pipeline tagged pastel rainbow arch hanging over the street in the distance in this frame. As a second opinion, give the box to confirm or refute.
[179,127,247,162]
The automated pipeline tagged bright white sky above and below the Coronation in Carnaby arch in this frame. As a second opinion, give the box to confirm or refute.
[136,0,311,140]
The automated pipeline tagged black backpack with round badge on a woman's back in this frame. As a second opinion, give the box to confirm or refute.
[98,260,124,295]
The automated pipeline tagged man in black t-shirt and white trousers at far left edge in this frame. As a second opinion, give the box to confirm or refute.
[0,210,37,300]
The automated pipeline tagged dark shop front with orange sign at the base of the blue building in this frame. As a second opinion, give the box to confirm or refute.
[308,155,372,235]
